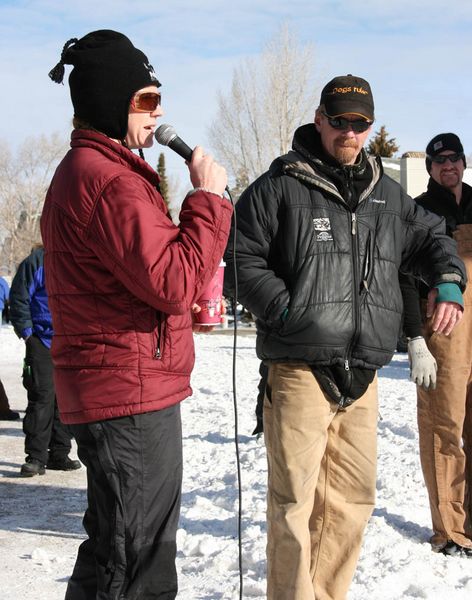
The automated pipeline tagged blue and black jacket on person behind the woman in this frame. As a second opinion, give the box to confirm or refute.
[10,248,54,348]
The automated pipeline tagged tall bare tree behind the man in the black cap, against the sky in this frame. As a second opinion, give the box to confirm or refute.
[209,25,317,191]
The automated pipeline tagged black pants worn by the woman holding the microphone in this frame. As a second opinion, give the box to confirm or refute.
[66,405,182,600]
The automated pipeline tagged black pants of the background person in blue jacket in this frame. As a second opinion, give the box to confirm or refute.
[23,335,71,463]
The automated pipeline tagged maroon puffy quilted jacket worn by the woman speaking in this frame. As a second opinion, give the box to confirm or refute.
[41,130,232,423]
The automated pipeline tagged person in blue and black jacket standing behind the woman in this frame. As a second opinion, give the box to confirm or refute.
[10,244,81,477]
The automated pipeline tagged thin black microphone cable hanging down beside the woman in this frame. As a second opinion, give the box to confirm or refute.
[225,187,243,600]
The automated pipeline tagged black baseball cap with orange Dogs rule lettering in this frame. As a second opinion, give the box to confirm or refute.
[320,74,374,121]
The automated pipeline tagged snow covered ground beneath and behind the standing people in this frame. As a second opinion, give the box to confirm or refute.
[0,326,472,600]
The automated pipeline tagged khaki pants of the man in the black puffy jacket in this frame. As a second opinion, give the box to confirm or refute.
[264,363,377,600]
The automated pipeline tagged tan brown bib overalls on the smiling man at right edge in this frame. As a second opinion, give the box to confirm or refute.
[418,225,472,548]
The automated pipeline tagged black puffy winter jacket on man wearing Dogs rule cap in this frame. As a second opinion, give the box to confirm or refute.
[225,125,465,369]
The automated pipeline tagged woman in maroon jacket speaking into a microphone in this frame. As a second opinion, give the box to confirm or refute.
[41,30,232,600]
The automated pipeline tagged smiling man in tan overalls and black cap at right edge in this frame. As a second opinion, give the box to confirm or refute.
[401,133,472,558]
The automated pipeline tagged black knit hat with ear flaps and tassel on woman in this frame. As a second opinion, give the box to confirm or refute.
[49,29,161,140]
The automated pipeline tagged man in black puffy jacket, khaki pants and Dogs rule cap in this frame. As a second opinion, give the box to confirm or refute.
[225,75,465,600]
